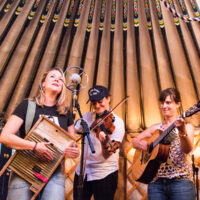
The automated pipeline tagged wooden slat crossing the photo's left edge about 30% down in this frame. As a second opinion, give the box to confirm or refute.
[0,0,35,75]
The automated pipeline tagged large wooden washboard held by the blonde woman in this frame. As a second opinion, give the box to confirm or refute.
[0,115,76,200]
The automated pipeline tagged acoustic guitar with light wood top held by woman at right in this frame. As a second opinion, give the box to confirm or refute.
[132,102,200,184]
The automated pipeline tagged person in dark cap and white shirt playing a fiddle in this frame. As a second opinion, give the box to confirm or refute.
[74,85,125,200]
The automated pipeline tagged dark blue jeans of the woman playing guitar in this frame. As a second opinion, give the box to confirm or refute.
[148,178,195,200]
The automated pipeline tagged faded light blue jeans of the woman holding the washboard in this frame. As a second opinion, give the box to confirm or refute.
[7,167,65,200]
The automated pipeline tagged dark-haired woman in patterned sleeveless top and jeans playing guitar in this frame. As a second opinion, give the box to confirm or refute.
[132,88,195,200]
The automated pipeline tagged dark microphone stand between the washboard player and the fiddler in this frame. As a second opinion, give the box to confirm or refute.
[75,100,95,200]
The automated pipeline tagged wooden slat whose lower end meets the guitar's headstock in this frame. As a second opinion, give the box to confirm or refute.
[161,1,197,123]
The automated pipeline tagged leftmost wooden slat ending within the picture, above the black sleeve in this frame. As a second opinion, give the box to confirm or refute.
[6,0,56,117]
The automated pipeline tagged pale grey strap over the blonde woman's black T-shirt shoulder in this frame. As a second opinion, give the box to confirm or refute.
[25,100,36,134]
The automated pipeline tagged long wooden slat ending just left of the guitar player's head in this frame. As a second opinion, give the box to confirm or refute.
[138,1,161,127]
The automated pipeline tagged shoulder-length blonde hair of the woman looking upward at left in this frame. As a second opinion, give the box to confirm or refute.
[34,67,69,115]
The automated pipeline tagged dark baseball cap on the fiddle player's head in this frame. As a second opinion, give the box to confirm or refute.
[88,85,110,101]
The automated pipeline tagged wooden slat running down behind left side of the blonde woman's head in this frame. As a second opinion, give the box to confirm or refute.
[30,1,69,97]
